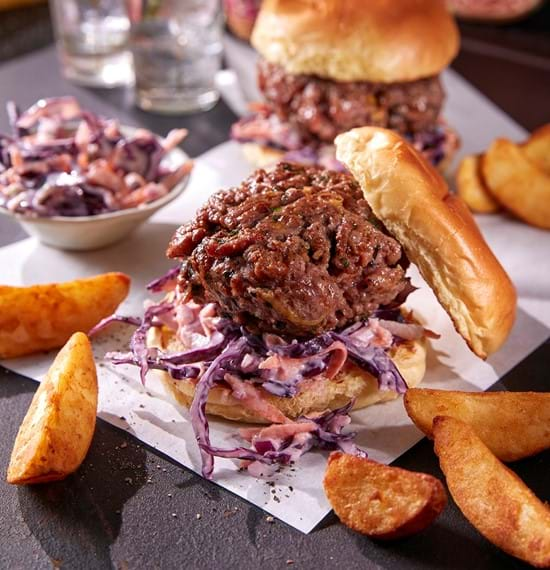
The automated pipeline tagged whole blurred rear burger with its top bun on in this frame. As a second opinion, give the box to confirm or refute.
[231,0,459,170]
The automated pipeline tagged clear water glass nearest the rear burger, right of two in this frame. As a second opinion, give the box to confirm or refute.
[130,0,223,114]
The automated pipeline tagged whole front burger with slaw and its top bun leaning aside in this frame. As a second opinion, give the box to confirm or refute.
[96,127,516,477]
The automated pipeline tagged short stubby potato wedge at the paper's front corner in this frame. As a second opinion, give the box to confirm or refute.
[323,452,447,540]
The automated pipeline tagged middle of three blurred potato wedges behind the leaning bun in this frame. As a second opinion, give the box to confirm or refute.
[481,139,550,229]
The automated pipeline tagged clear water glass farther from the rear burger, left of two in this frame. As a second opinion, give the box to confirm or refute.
[50,0,134,87]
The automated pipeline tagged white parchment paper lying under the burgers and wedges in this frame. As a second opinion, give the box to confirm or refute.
[0,47,550,532]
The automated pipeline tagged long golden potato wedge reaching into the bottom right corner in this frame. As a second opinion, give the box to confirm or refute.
[433,416,550,568]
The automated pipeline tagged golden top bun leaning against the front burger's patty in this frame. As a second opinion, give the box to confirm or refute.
[335,127,516,358]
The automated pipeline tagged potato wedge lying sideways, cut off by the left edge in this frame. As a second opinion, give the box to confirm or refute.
[0,273,130,358]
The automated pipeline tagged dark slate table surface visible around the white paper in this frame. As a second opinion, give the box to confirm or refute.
[0,6,550,570]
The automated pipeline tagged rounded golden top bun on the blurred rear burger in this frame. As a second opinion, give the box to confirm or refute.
[251,0,460,83]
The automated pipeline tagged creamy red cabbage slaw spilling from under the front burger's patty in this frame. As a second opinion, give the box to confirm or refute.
[90,268,424,478]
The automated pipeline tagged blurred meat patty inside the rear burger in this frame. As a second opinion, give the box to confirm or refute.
[258,60,445,142]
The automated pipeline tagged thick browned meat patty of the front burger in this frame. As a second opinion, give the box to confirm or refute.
[167,163,408,337]
